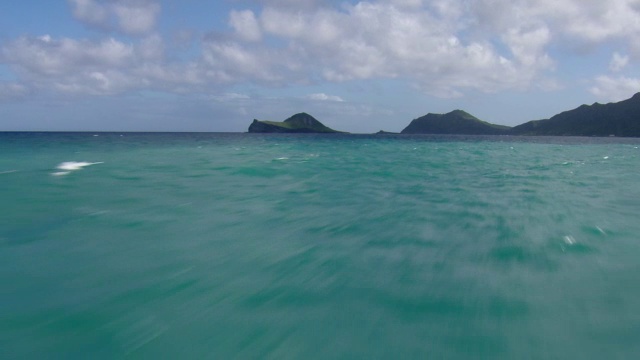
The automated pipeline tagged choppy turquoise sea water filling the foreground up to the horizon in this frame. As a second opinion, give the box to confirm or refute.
[0,133,640,359]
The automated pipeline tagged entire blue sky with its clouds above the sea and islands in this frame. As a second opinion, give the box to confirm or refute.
[0,0,640,133]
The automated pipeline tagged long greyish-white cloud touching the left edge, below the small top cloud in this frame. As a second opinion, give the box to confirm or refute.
[0,35,205,94]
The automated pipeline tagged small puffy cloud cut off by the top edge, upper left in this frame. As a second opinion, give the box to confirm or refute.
[68,0,160,35]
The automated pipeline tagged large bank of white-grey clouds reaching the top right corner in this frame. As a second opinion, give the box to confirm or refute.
[232,0,640,97]
